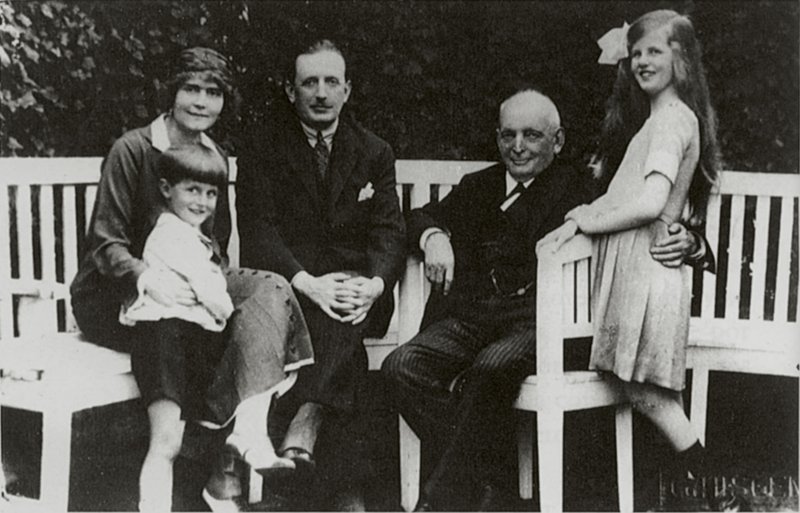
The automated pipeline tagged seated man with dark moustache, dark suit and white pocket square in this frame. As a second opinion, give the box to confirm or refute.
[236,40,405,508]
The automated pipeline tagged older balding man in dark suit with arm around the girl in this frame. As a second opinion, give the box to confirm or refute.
[382,89,708,511]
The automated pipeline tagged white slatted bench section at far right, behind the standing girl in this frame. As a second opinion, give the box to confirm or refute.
[687,173,800,446]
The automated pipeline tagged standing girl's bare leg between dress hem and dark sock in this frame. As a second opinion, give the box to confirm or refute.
[624,382,698,452]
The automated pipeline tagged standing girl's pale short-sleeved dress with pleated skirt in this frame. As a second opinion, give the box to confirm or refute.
[589,100,700,390]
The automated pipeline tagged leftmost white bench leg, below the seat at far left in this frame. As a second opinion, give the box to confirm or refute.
[39,408,72,512]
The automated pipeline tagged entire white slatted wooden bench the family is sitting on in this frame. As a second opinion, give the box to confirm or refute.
[0,158,800,511]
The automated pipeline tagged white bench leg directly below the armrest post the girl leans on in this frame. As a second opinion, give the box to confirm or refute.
[536,410,564,513]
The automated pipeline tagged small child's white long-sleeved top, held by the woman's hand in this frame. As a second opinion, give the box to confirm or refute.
[119,212,233,332]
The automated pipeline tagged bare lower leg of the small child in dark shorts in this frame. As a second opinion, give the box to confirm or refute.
[139,399,186,513]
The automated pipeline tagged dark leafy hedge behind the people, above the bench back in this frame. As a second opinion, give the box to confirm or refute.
[0,0,800,173]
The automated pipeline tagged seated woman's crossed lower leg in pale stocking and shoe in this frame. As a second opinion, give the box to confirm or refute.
[227,372,296,469]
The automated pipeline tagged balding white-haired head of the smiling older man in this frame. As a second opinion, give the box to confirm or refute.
[497,90,564,182]
